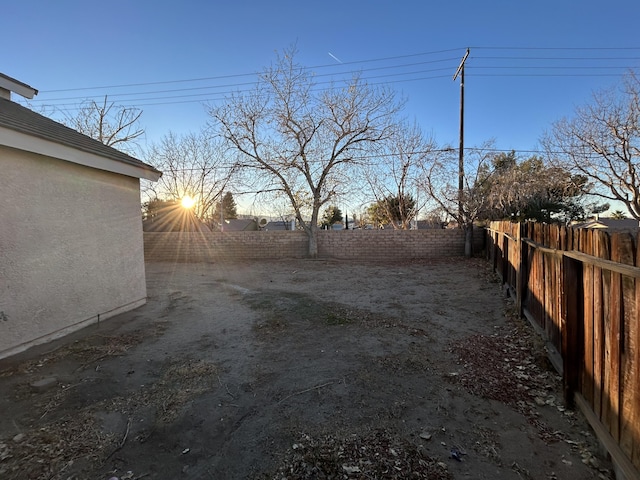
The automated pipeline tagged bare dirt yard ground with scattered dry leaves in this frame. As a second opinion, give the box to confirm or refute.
[0,259,613,480]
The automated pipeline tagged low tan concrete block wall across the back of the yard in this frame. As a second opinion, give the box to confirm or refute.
[144,230,483,263]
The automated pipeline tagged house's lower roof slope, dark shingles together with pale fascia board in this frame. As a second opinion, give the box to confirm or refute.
[0,98,162,181]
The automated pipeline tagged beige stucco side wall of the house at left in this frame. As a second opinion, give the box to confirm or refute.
[0,146,146,358]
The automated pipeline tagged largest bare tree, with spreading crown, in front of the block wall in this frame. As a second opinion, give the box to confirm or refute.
[209,48,401,257]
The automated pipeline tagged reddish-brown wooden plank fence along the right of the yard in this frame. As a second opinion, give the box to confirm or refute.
[486,222,640,480]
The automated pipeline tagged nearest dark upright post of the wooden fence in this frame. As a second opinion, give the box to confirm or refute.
[561,256,584,407]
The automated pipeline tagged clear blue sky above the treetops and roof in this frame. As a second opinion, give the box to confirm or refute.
[0,0,640,159]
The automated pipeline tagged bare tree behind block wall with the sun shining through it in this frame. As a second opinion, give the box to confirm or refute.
[147,131,233,222]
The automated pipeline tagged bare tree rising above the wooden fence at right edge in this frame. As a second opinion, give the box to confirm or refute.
[542,73,640,220]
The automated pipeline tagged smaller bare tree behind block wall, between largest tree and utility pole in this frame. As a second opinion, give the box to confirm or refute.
[365,123,435,230]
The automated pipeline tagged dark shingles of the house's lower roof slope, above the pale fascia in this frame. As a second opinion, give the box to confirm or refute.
[0,98,160,178]
